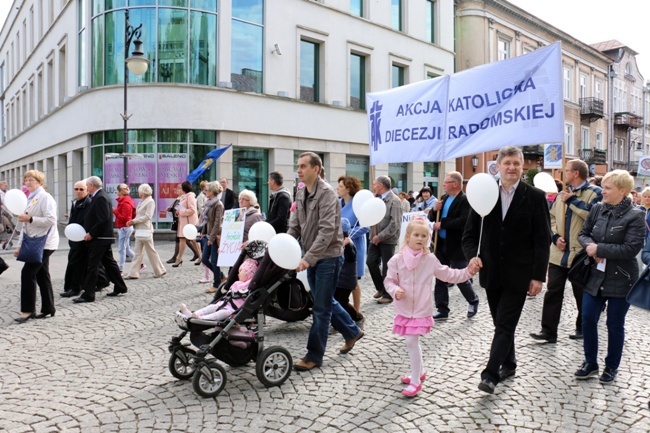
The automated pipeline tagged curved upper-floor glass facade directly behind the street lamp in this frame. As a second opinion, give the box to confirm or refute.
[92,0,218,87]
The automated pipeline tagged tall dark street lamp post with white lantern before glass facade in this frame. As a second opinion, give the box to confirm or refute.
[121,9,149,190]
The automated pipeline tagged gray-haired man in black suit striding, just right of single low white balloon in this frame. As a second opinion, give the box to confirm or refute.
[74,176,127,303]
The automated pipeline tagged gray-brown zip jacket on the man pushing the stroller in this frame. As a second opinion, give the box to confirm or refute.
[287,179,343,266]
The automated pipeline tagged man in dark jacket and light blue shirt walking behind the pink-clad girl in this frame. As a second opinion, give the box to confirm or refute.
[429,171,478,320]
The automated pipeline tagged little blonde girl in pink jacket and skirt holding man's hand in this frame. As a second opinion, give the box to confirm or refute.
[384,219,481,397]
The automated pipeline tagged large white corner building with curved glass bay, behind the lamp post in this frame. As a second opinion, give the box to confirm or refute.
[0,0,454,228]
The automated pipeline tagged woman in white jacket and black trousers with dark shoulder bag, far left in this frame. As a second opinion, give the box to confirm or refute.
[14,170,59,323]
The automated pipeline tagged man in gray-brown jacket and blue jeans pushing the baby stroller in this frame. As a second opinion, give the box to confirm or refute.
[287,152,363,371]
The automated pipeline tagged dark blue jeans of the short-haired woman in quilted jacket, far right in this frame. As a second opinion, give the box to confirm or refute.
[582,293,630,370]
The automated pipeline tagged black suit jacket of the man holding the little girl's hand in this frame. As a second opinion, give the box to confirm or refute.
[462,181,551,290]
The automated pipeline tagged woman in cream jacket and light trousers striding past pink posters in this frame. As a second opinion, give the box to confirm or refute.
[126,183,167,280]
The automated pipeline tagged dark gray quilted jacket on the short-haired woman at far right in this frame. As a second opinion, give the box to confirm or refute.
[578,203,646,298]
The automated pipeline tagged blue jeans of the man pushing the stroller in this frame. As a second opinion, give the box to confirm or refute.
[307,257,360,364]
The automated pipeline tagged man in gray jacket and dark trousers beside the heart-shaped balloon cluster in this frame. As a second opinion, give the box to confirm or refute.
[366,176,403,304]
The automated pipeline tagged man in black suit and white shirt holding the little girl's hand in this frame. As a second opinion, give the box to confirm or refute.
[462,146,551,394]
